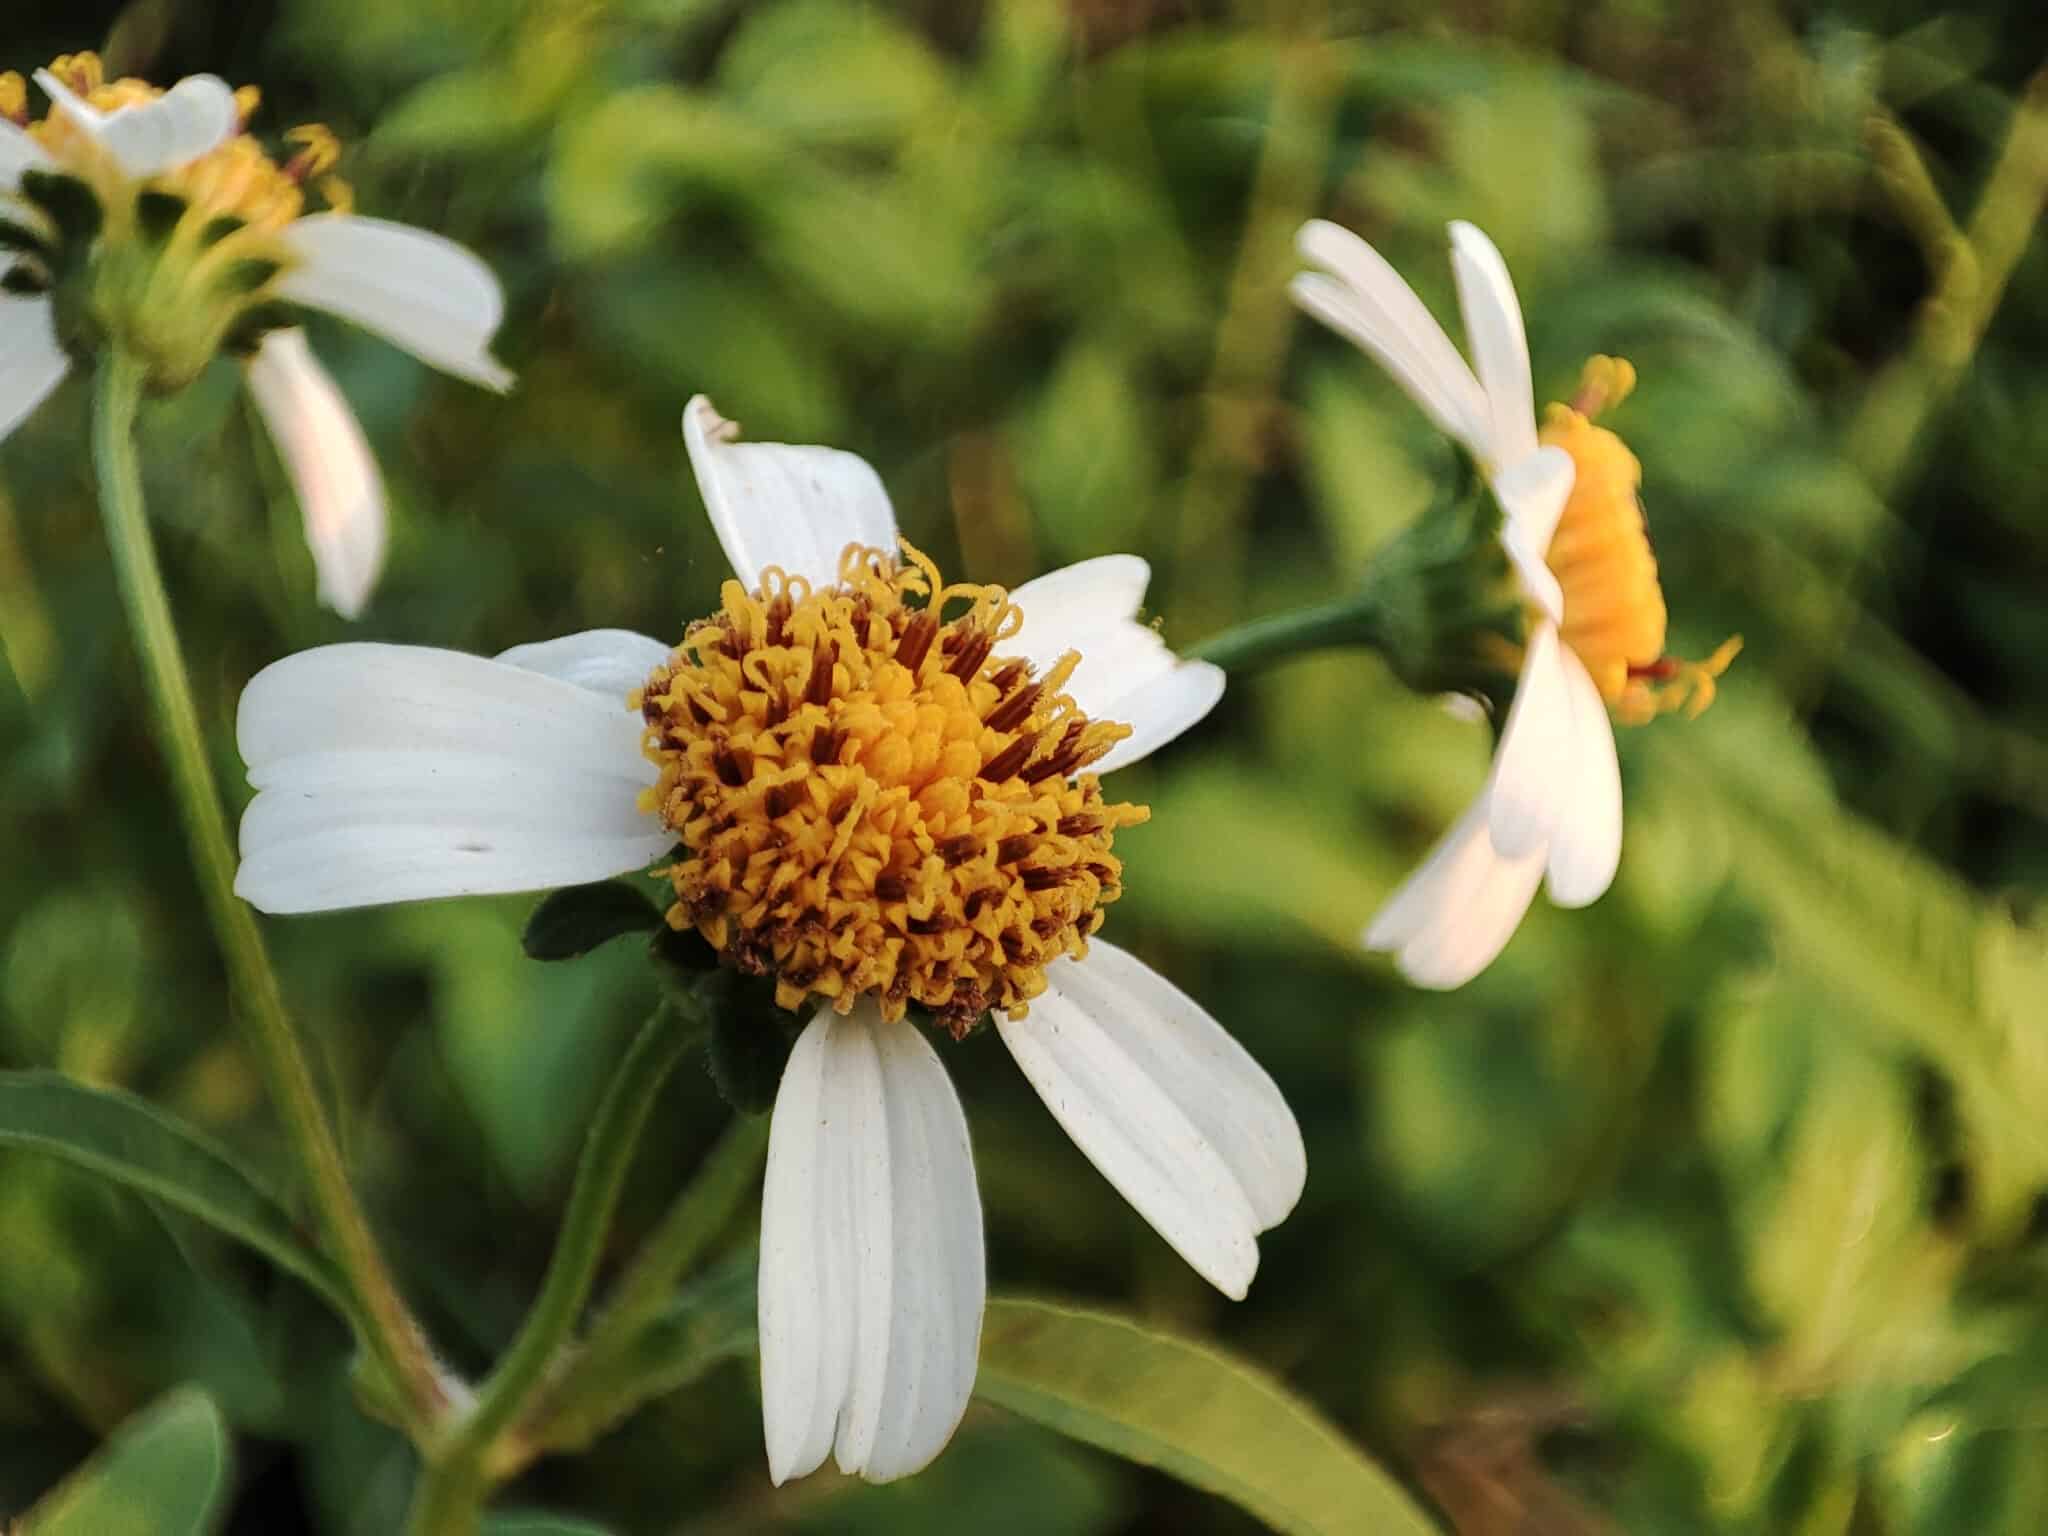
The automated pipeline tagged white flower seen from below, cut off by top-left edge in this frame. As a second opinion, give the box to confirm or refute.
[0,53,512,618]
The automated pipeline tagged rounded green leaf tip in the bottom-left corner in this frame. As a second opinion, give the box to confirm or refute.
[20,1386,227,1536]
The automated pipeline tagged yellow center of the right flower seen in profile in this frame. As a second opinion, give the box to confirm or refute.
[1540,356,1743,725]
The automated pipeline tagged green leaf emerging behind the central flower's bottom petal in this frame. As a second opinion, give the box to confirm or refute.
[975,1298,1436,1536]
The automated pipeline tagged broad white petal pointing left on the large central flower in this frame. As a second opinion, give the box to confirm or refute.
[236,645,674,911]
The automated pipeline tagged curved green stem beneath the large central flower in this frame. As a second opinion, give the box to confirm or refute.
[408,1004,702,1536]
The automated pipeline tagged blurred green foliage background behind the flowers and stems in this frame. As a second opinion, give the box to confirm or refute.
[0,0,2048,1536]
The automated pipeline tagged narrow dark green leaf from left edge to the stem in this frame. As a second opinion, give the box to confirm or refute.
[0,1071,354,1319]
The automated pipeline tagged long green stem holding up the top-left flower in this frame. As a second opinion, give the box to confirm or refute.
[92,350,446,1438]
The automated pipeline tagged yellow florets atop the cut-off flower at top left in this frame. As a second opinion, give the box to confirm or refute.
[0,53,352,231]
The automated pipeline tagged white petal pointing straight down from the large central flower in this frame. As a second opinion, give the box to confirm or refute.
[758,1004,985,1483]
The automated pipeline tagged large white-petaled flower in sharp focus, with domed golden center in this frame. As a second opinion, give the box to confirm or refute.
[236,397,1307,1483]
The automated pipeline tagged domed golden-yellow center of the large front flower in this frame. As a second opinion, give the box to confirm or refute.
[637,545,1151,1034]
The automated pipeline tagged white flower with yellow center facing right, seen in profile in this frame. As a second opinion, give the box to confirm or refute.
[1290,219,1735,987]
